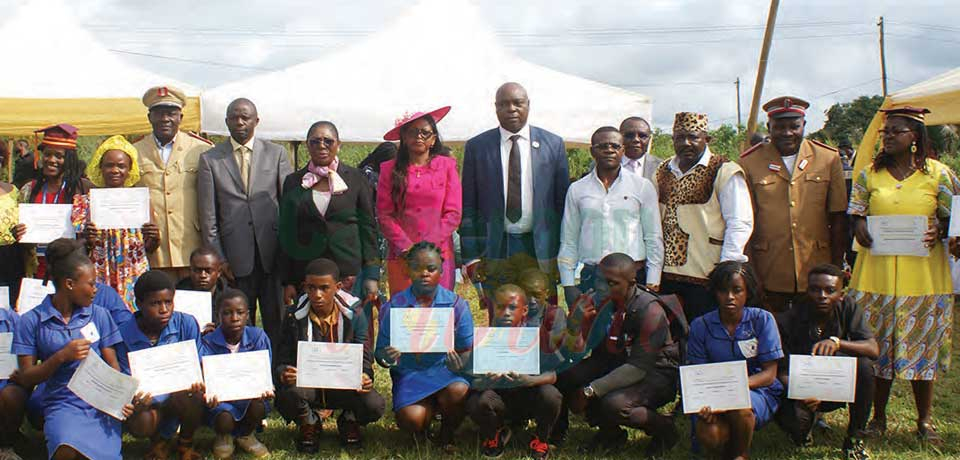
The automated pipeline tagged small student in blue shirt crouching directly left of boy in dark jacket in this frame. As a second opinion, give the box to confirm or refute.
[200,288,273,459]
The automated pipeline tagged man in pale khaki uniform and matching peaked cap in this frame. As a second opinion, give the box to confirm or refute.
[134,86,213,279]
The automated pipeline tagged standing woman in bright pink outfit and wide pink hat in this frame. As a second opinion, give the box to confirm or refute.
[377,107,462,296]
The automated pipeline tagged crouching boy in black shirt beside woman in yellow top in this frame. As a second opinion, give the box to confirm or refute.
[776,264,880,459]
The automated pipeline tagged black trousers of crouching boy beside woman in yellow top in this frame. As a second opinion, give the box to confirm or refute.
[774,357,874,444]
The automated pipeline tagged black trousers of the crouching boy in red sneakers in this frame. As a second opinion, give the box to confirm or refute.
[467,385,563,442]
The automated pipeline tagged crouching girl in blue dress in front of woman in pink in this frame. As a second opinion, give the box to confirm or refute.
[375,243,473,452]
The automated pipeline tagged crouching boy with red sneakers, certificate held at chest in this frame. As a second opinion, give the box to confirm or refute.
[447,284,563,460]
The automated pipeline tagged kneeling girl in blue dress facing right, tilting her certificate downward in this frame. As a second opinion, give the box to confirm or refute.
[13,253,133,460]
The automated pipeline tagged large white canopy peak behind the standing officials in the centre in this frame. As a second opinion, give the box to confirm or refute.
[201,0,652,142]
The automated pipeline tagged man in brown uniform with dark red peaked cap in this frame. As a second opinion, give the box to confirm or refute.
[740,96,847,312]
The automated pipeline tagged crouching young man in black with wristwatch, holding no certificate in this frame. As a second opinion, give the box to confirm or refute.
[560,253,684,457]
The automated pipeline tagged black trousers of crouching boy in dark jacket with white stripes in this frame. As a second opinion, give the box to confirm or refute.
[277,387,386,425]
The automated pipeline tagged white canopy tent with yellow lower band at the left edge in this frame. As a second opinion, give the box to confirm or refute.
[0,0,200,136]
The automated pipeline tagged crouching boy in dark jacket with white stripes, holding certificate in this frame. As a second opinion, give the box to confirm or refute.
[276,259,386,453]
